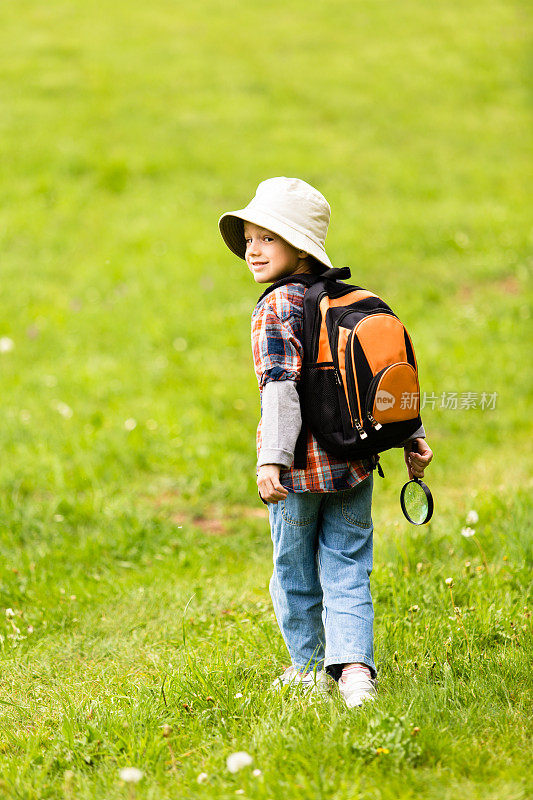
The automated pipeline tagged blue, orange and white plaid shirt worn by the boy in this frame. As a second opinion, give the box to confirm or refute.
[252,283,371,492]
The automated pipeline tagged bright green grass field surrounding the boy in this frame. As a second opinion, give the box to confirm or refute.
[0,0,533,800]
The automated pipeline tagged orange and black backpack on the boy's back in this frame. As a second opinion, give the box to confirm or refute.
[260,267,422,472]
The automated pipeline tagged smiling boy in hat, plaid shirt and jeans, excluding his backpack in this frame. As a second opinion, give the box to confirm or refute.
[219,177,433,707]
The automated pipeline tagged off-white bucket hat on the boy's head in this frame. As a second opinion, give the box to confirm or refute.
[218,178,332,267]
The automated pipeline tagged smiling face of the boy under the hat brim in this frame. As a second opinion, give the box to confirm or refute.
[244,222,309,283]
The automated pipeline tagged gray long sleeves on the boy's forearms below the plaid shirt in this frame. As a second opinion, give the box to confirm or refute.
[257,381,426,468]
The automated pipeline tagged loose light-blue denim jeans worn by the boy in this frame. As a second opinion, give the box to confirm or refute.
[267,473,376,677]
